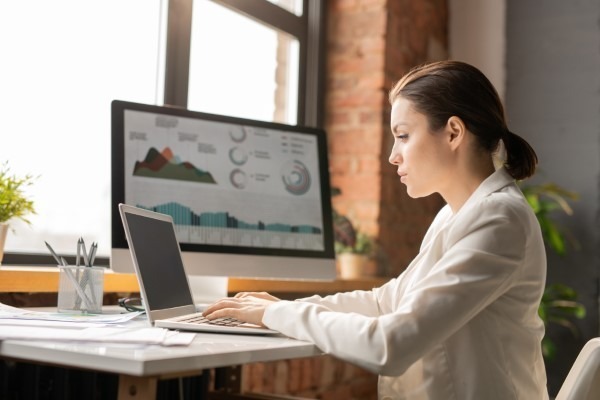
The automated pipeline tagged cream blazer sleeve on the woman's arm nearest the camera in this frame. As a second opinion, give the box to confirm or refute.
[263,198,528,375]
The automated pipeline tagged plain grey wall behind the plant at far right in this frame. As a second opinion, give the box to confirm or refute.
[506,0,600,394]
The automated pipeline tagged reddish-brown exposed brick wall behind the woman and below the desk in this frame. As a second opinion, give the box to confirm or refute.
[242,0,448,400]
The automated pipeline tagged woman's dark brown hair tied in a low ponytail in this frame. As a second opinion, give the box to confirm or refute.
[389,61,538,180]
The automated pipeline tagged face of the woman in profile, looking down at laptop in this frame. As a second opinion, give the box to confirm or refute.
[389,98,452,198]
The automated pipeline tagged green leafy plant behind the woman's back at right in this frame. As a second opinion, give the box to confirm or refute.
[521,183,586,360]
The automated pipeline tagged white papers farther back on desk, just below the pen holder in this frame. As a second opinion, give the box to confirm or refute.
[0,303,143,324]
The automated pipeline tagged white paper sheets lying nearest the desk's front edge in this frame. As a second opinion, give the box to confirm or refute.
[0,325,195,346]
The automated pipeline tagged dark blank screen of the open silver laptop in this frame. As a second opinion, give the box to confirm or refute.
[124,212,194,310]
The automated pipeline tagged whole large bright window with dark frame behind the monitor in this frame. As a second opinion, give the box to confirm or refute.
[0,0,324,264]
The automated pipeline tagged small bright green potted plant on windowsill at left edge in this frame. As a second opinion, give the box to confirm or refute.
[0,162,35,263]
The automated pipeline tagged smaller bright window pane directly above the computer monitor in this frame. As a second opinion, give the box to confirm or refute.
[187,1,299,124]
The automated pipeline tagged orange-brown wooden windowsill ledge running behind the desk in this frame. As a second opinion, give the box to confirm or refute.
[0,266,388,294]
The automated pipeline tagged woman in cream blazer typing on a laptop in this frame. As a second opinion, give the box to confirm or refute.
[205,61,548,400]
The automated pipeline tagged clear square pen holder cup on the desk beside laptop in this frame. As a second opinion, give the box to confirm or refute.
[57,266,104,314]
